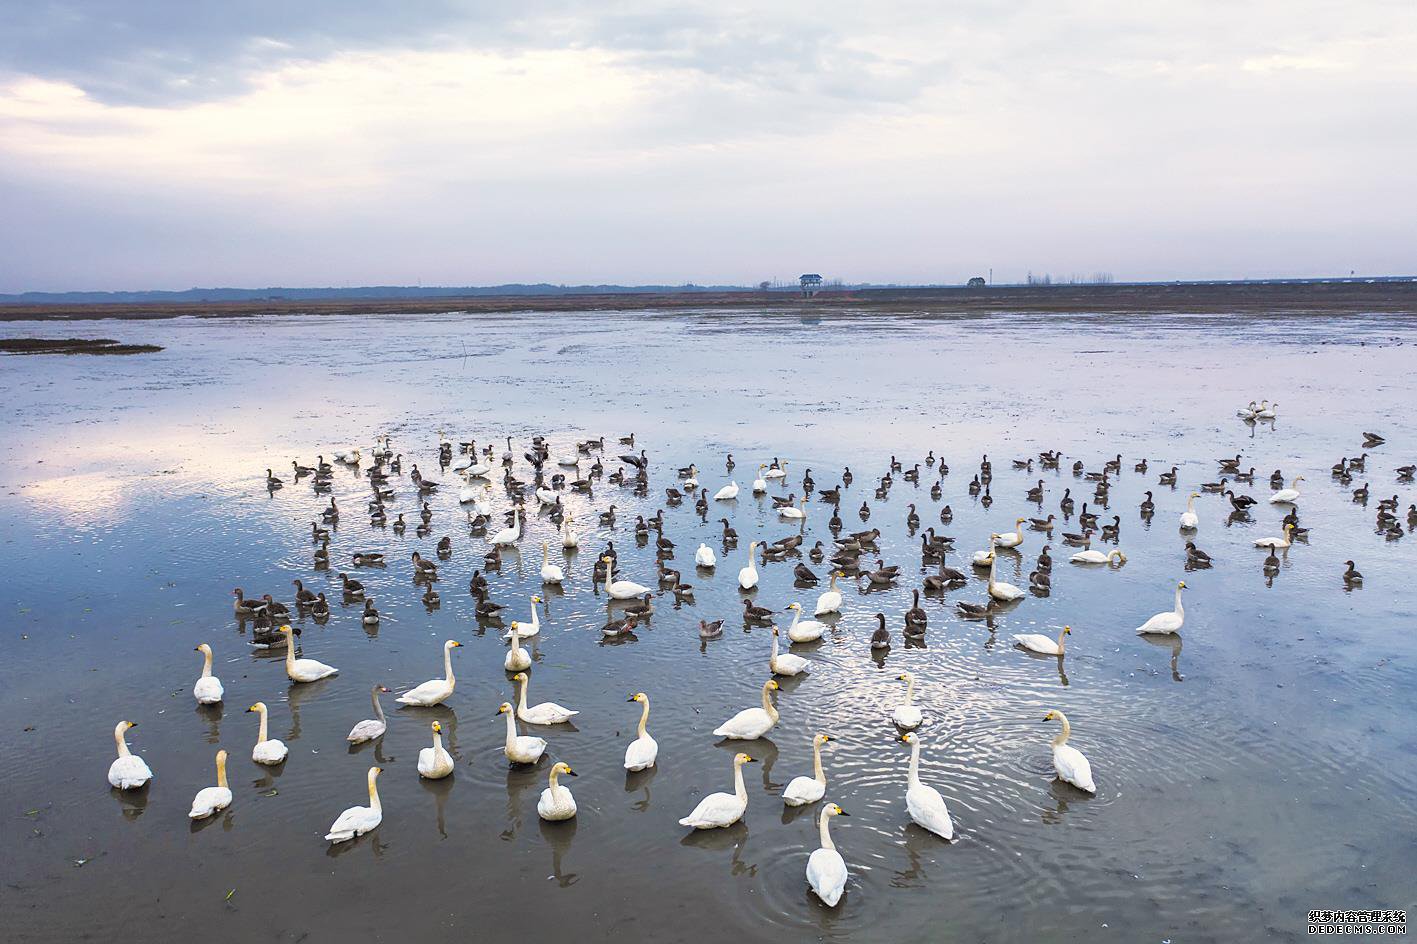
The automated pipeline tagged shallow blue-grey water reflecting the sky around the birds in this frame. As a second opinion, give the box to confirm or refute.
[0,304,1417,941]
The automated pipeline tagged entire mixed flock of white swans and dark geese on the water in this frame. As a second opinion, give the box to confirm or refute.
[108,416,1417,907]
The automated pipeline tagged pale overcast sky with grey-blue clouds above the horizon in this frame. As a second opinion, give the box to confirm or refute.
[0,0,1417,292]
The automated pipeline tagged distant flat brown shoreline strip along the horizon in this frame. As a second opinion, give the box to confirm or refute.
[0,279,1417,322]
